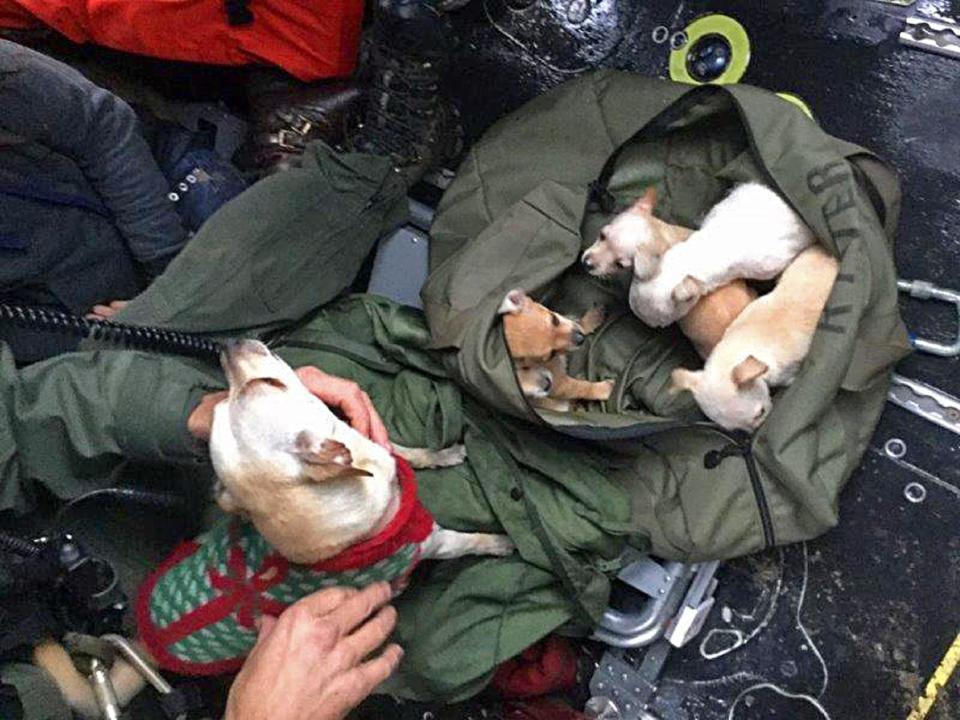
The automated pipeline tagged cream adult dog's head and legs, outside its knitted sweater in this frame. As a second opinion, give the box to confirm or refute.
[40,340,514,718]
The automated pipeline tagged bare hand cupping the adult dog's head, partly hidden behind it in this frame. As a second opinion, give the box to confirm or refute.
[187,366,390,449]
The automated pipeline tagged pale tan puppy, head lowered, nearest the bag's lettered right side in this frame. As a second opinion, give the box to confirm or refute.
[673,245,837,430]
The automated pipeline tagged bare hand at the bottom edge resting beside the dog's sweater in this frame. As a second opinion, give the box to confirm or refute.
[225,583,403,720]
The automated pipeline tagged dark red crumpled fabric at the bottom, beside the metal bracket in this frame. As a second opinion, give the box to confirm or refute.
[491,635,577,698]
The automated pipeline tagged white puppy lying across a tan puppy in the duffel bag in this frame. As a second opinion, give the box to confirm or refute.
[630,183,815,327]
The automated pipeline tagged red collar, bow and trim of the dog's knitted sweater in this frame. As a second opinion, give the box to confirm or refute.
[136,456,433,675]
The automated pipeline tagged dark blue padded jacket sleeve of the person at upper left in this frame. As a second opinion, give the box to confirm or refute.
[0,40,187,272]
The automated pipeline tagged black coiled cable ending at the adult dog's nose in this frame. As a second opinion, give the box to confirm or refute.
[0,303,221,361]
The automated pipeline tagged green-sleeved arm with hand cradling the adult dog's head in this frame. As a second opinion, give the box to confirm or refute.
[0,344,389,513]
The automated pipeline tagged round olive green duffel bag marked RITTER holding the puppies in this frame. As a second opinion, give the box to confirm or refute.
[423,71,909,560]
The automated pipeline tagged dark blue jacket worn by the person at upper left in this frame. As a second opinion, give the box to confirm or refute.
[0,40,187,359]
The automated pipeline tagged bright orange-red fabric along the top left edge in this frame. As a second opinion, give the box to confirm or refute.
[0,0,363,82]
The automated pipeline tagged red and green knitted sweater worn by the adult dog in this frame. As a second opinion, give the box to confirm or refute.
[137,458,433,675]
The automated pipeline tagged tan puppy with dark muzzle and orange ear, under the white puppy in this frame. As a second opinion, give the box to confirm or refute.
[581,187,757,358]
